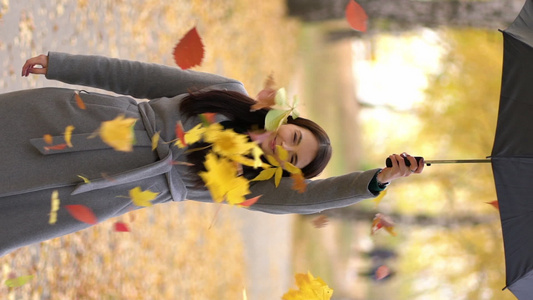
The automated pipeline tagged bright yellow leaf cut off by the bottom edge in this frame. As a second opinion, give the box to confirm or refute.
[281,272,333,300]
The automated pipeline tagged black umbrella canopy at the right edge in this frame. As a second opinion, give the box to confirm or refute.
[492,0,533,299]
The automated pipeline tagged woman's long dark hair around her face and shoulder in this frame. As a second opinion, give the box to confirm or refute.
[180,90,332,178]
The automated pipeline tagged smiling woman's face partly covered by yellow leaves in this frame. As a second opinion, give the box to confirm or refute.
[261,124,318,169]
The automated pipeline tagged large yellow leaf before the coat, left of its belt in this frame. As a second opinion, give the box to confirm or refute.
[99,115,137,152]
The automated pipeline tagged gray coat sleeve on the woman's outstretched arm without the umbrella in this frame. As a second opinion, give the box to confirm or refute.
[46,52,245,99]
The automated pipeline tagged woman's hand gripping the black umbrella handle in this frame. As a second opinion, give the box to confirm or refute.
[377,152,424,183]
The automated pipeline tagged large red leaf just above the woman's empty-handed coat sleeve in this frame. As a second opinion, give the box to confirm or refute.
[174,27,204,70]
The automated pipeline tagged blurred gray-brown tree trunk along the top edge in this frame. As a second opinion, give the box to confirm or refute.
[287,0,524,30]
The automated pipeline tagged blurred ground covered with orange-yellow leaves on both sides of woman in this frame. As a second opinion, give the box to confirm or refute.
[0,0,298,299]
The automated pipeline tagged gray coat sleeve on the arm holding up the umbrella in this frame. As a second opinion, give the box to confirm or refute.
[250,169,379,214]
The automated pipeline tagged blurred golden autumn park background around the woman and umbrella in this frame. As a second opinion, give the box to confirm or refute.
[0,0,524,300]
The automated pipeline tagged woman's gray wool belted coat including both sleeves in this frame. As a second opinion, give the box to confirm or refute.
[0,52,376,255]
